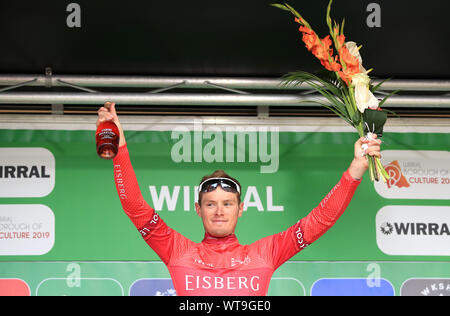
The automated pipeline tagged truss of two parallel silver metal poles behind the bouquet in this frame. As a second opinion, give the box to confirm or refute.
[0,73,450,108]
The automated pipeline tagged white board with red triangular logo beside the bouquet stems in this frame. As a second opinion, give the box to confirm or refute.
[374,150,450,200]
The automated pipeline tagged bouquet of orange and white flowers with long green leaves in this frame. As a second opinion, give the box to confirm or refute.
[272,0,396,182]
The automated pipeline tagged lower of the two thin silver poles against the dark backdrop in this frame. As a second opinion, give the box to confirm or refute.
[0,92,450,108]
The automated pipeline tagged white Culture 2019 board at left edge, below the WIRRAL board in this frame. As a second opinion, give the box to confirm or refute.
[0,204,55,256]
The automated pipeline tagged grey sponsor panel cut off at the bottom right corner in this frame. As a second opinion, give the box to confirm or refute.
[400,279,450,296]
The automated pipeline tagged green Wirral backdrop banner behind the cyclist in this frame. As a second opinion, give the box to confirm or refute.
[0,127,450,295]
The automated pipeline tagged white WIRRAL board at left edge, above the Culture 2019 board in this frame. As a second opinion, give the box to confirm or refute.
[0,148,55,197]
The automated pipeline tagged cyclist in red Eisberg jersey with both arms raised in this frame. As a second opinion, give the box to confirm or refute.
[97,103,380,296]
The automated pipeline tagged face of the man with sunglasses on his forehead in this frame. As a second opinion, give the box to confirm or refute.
[195,186,244,237]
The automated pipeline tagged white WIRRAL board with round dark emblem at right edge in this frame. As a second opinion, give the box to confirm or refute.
[376,205,450,256]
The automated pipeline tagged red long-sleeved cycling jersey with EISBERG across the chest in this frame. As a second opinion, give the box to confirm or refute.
[114,145,360,296]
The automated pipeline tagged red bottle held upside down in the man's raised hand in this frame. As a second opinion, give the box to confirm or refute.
[95,102,120,159]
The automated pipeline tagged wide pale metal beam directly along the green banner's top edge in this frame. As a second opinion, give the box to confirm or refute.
[0,114,450,134]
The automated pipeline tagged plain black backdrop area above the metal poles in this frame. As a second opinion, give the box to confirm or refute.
[0,0,450,79]
